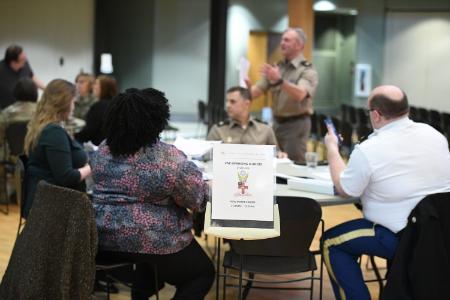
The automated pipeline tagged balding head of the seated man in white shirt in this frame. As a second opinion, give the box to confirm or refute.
[368,85,409,120]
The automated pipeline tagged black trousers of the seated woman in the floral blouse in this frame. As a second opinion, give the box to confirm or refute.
[98,239,215,300]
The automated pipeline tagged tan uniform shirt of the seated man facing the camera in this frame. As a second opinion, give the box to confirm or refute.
[206,117,277,145]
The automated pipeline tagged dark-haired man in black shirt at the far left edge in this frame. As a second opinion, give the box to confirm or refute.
[0,45,45,109]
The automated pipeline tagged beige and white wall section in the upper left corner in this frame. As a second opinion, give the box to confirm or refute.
[0,0,94,82]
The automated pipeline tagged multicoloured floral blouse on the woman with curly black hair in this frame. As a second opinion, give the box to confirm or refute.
[90,142,209,254]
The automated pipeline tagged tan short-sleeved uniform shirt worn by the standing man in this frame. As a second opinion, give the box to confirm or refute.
[256,55,319,117]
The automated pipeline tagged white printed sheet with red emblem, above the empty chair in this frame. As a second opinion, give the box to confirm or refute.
[211,144,275,221]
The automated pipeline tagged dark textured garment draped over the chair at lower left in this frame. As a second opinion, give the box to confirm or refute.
[0,181,97,300]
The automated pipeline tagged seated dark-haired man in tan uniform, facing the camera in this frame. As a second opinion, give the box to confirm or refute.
[207,86,286,157]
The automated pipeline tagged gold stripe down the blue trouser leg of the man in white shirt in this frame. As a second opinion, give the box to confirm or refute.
[323,224,375,300]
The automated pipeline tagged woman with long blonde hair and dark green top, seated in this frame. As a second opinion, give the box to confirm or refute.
[23,79,91,217]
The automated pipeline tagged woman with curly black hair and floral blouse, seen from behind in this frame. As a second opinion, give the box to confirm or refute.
[90,89,215,300]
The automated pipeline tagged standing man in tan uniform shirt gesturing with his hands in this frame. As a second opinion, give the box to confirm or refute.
[248,28,318,162]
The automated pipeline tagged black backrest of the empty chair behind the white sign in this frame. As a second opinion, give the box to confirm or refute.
[230,197,322,257]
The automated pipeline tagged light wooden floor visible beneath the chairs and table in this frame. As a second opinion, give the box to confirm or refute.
[0,205,384,300]
